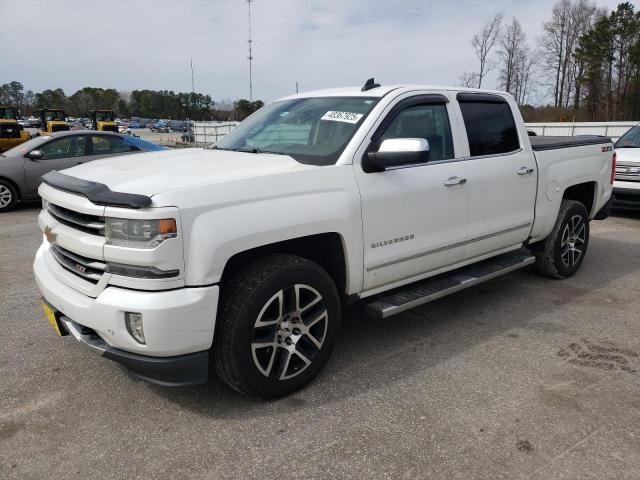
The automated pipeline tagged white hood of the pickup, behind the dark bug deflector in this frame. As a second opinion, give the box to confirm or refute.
[63,148,318,197]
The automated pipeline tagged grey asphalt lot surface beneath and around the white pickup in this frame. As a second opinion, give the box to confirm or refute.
[0,205,640,479]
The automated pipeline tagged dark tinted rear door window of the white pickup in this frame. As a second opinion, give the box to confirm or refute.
[458,94,520,157]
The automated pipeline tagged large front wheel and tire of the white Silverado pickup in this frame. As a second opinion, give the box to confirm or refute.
[213,254,341,399]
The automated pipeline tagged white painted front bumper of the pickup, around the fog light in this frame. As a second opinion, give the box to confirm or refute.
[33,247,219,384]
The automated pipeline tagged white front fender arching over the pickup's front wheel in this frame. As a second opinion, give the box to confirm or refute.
[154,160,362,294]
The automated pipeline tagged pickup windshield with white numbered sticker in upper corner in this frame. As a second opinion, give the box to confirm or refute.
[211,97,378,165]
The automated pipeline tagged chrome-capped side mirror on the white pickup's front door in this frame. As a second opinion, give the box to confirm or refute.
[362,138,429,173]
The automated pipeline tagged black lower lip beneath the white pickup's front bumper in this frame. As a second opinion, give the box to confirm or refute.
[60,316,209,387]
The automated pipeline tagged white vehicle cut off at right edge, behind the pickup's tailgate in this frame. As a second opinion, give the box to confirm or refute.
[613,124,640,211]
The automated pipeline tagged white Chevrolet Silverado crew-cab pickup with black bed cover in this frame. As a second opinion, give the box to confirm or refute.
[34,80,615,398]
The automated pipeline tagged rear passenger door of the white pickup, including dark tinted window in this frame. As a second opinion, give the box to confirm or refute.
[457,93,537,259]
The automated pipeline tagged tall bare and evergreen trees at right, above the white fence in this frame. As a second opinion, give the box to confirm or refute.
[460,0,640,121]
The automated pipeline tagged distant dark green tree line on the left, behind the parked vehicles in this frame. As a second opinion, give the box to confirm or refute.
[0,81,264,120]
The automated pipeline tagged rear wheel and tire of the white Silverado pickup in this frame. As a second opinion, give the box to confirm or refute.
[533,200,589,278]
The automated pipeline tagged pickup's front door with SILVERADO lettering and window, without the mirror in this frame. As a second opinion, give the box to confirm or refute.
[354,92,469,293]
